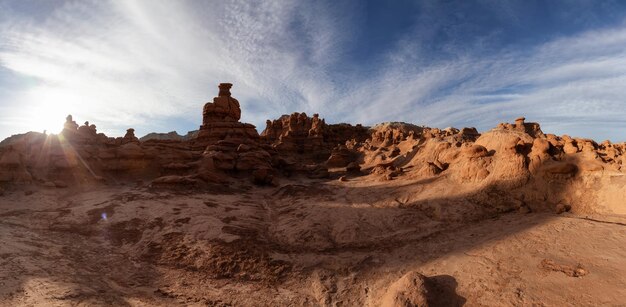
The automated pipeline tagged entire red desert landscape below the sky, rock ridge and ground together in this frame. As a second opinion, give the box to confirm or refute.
[0,83,626,306]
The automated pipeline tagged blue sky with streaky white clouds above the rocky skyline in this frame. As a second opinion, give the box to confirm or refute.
[0,0,626,142]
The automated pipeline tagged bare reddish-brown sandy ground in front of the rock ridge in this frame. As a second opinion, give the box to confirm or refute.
[0,179,626,306]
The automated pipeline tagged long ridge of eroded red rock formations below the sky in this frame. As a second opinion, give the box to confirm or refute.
[0,83,626,217]
